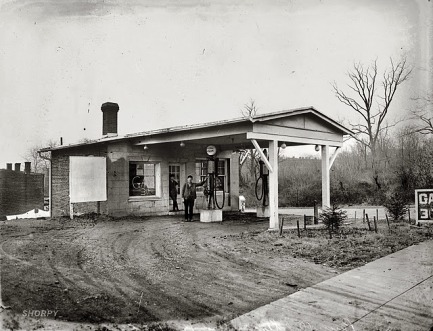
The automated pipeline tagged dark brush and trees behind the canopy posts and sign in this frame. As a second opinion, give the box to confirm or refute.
[241,126,433,207]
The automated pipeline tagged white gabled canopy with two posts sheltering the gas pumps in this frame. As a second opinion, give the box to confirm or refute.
[132,107,352,229]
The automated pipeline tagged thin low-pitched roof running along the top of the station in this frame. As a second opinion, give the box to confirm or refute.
[40,107,353,152]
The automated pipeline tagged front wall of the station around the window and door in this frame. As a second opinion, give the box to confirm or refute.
[107,142,239,216]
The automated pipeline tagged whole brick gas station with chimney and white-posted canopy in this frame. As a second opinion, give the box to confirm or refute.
[40,102,351,229]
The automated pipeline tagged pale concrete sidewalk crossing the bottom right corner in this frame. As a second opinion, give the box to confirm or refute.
[232,240,433,331]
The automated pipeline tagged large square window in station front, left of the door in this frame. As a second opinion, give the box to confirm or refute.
[129,161,161,197]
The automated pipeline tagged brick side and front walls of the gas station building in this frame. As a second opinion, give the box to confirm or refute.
[51,141,239,216]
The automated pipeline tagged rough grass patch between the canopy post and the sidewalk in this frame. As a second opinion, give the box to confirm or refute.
[235,223,433,271]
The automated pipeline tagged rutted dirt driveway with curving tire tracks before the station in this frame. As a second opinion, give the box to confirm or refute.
[0,215,336,323]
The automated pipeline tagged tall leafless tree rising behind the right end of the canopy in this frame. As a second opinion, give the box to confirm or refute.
[333,58,412,188]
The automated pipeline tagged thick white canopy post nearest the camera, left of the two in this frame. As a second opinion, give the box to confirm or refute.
[269,140,279,230]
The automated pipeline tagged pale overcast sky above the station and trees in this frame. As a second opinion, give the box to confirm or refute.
[0,0,433,168]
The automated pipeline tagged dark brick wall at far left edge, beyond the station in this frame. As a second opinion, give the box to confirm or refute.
[0,170,44,218]
